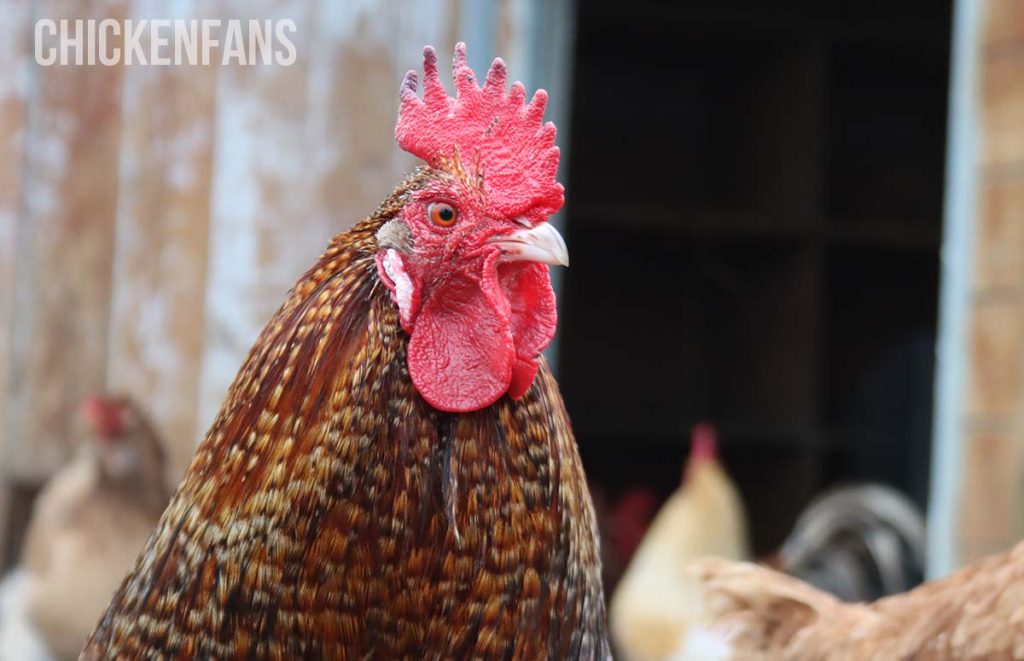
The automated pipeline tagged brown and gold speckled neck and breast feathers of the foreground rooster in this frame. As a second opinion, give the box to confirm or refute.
[82,168,609,659]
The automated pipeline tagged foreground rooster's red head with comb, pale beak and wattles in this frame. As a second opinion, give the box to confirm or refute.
[376,44,568,412]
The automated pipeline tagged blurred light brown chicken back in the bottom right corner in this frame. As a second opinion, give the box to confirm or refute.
[676,544,1024,661]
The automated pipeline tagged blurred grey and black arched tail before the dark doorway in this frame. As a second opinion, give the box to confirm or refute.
[770,484,926,602]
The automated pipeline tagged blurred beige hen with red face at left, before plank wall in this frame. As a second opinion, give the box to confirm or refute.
[6,397,170,661]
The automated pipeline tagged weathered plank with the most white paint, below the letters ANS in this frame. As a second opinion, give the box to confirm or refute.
[197,2,312,437]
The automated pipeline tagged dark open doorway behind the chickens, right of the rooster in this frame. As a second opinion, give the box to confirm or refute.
[559,0,951,554]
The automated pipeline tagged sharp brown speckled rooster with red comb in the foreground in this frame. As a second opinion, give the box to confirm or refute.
[82,44,609,659]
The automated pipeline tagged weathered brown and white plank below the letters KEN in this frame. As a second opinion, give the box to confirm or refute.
[109,0,218,482]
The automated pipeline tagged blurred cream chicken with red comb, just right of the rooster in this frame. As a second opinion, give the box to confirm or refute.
[609,424,748,661]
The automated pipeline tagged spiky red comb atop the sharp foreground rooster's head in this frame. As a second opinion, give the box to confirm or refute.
[394,43,563,222]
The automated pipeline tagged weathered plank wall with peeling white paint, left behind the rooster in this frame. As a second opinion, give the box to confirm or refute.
[0,0,561,530]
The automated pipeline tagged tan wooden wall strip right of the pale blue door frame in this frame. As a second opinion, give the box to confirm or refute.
[959,0,1024,562]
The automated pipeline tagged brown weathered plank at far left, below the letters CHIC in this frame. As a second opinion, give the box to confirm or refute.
[4,0,124,479]
